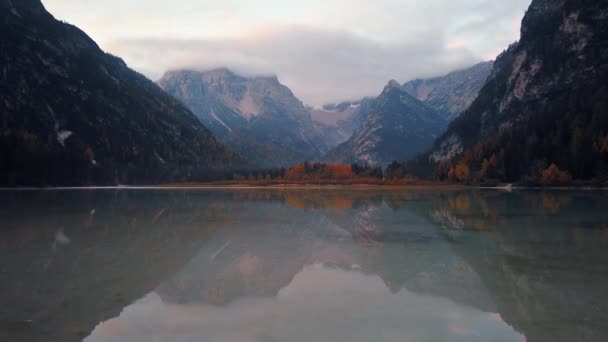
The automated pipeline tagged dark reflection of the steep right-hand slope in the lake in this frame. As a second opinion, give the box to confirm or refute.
[428,192,608,341]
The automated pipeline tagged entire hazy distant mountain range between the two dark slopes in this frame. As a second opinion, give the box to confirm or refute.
[158,62,492,167]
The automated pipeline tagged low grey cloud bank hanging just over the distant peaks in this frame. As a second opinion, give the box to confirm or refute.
[106,27,481,105]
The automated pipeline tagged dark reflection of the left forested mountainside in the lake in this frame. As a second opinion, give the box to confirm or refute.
[0,191,238,342]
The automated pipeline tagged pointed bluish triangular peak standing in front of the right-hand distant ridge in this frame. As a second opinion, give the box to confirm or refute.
[325,81,446,165]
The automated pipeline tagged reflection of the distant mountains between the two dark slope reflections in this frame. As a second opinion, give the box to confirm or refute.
[157,190,493,311]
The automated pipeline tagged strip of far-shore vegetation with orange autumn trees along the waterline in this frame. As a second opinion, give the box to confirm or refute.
[0,162,608,191]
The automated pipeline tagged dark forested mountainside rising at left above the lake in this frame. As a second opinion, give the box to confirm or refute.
[0,0,241,186]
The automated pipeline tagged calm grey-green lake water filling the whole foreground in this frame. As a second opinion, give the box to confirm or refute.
[0,189,608,342]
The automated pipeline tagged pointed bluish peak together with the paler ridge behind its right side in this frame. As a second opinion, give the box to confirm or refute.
[324,62,493,166]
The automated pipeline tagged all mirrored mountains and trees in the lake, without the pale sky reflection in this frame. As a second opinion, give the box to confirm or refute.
[0,189,608,341]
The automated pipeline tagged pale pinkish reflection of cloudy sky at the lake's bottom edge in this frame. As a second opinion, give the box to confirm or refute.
[86,265,521,342]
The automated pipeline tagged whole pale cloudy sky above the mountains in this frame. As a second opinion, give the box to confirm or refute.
[43,0,531,105]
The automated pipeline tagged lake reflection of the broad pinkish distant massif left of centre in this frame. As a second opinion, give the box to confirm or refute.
[157,203,324,305]
